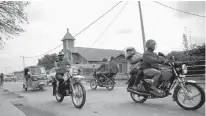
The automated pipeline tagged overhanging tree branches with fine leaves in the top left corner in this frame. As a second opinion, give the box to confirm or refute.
[0,1,29,49]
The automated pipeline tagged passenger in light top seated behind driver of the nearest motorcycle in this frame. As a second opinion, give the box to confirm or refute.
[125,47,143,91]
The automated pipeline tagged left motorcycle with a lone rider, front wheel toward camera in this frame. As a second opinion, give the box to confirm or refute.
[55,66,86,108]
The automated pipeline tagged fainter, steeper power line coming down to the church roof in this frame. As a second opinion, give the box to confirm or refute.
[90,1,128,47]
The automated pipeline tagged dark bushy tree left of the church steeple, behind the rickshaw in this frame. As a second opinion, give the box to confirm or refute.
[38,54,57,70]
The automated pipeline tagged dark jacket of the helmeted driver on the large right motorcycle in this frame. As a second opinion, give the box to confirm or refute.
[142,49,164,69]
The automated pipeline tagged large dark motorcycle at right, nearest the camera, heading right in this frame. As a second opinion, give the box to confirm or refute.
[127,53,205,110]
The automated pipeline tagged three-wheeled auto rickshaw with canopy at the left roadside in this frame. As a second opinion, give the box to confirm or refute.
[23,66,47,91]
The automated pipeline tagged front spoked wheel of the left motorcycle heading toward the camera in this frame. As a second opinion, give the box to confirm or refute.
[71,82,86,108]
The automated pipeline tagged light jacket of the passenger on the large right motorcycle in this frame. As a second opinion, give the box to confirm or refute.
[127,53,142,71]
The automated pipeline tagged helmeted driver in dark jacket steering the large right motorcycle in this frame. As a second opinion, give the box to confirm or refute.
[143,40,166,96]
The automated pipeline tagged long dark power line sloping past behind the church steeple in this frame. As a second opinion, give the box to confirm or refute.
[25,1,122,58]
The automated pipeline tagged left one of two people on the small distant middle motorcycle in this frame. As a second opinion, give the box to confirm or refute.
[96,58,110,81]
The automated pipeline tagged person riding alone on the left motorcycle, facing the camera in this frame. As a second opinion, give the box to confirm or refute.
[53,51,70,95]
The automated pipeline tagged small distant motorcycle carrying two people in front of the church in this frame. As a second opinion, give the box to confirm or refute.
[90,71,115,91]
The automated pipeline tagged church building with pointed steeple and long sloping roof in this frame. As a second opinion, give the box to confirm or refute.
[62,29,132,75]
